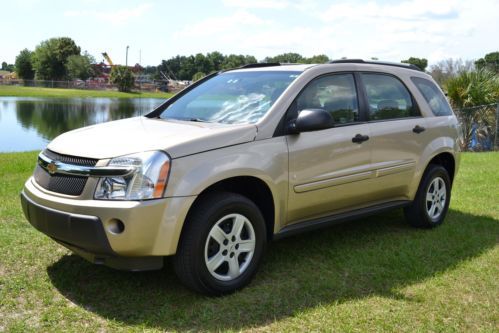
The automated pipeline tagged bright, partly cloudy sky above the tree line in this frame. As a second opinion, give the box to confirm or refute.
[0,0,499,66]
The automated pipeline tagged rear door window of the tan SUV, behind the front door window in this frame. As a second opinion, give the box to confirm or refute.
[361,73,420,120]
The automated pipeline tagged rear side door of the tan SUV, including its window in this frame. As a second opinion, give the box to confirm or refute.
[358,72,431,201]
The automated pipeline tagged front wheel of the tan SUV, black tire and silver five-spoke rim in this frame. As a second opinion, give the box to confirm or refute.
[173,192,267,296]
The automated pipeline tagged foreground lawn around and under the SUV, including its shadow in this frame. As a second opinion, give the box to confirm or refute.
[0,153,499,332]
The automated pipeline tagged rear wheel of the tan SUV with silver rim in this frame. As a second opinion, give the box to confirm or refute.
[404,164,451,228]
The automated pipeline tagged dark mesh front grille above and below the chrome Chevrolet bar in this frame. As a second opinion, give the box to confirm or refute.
[34,149,98,195]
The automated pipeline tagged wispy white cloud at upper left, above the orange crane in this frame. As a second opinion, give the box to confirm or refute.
[64,3,152,24]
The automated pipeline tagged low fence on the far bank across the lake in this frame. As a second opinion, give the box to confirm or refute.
[0,79,165,91]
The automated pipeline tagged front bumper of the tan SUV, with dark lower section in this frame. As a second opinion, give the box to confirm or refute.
[21,178,195,270]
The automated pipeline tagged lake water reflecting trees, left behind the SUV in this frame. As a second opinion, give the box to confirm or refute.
[0,97,164,152]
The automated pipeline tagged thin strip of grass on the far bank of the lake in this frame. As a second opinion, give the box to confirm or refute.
[0,85,173,98]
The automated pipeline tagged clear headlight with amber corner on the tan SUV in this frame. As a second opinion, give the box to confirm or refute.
[94,151,170,200]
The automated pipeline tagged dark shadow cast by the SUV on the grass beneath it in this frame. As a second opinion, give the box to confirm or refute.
[47,210,499,331]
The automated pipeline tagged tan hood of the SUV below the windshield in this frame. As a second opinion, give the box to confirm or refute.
[47,117,257,159]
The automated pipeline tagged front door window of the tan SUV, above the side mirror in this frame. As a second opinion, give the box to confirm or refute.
[296,74,359,124]
